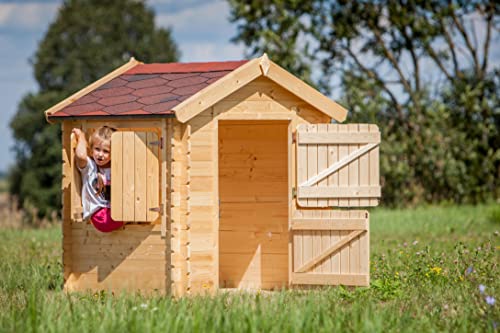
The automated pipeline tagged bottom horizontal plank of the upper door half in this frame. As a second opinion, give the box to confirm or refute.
[297,186,381,199]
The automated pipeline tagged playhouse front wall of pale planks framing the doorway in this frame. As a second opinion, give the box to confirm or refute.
[184,78,330,294]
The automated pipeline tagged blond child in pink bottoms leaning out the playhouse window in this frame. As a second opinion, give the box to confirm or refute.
[71,126,123,232]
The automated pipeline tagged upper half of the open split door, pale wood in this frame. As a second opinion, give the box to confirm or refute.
[296,124,381,207]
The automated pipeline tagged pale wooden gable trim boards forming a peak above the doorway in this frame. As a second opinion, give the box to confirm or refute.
[172,54,347,123]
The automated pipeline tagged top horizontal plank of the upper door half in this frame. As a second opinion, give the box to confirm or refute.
[297,131,380,145]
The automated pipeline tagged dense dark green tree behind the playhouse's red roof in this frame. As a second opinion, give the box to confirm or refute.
[10,0,179,215]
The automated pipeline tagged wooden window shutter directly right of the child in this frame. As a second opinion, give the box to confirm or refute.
[111,131,161,222]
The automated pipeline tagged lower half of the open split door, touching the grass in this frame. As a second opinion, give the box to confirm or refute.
[291,210,370,286]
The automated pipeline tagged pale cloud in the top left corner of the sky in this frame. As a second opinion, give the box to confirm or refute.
[0,2,60,31]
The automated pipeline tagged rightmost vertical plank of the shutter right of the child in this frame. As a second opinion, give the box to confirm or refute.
[146,132,160,222]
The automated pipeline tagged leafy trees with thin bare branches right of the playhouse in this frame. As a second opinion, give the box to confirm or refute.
[228,0,500,204]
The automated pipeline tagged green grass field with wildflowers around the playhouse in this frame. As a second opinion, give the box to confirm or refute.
[0,204,500,332]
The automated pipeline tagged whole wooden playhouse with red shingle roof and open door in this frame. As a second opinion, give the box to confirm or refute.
[46,55,380,296]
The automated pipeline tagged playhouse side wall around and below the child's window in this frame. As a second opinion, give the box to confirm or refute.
[62,121,170,293]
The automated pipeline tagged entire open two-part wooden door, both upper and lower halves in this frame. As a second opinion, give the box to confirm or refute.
[290,124,381,286]
